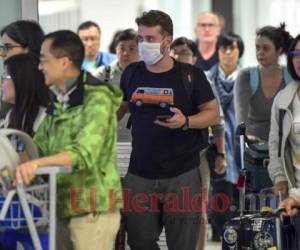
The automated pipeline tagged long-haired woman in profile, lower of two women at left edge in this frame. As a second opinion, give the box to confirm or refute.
[2,53,49,135]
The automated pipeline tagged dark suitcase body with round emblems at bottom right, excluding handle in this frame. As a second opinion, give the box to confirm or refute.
[222,213,299,250]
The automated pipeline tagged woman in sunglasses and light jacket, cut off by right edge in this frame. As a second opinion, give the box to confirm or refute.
[268,35,300,237]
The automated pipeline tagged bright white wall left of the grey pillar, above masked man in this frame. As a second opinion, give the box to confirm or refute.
[39,0,211,51]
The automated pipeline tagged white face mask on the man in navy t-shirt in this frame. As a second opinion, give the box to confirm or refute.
[139,42,164,65]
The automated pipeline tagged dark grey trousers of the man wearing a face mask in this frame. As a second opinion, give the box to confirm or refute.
[123,168,202,250]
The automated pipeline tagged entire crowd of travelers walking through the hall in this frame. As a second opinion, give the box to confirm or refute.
[0,10,300,250]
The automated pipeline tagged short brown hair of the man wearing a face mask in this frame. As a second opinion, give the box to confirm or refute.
[135,10,173,35]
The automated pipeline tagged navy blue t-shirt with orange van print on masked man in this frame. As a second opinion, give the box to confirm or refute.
[121,61,215,179]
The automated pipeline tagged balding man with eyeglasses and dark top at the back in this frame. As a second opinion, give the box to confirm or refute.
[195,12,221,71]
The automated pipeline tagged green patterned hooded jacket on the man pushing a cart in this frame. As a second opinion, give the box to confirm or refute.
[34,74,123,217]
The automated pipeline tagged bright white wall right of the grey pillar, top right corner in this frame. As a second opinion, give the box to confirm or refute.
[234,0,300,65]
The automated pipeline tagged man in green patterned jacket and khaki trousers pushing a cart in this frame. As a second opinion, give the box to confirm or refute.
[16,30,122,250]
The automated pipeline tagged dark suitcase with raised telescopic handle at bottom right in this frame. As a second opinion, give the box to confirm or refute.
[222,125,298,250]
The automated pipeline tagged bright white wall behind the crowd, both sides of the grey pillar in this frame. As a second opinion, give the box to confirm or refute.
[39,0,300,65]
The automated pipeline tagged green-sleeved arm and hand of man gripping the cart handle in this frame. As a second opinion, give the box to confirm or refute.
[16,86,116,184]
